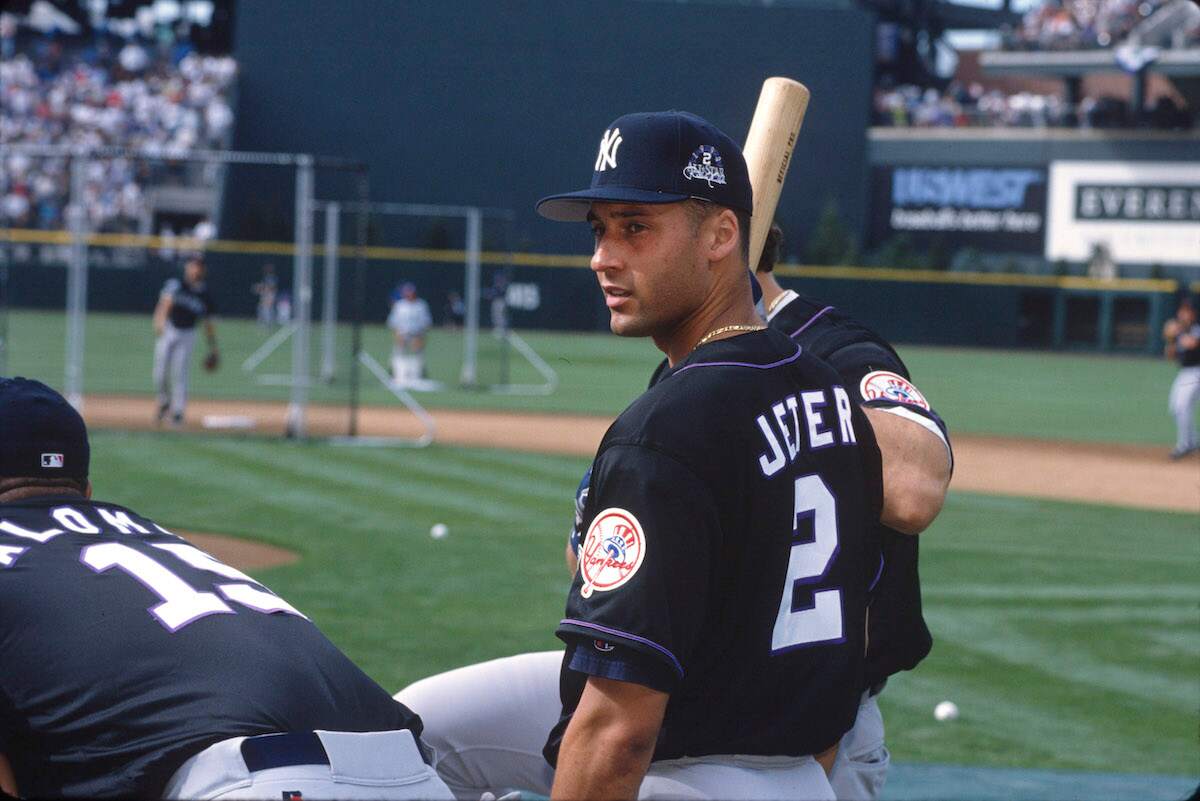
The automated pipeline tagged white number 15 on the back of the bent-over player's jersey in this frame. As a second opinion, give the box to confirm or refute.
[79,542,307,632]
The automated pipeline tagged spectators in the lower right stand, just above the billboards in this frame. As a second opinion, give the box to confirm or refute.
[874,82,1192,130]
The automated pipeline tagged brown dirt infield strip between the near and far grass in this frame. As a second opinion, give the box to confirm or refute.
[84,396,1200,512]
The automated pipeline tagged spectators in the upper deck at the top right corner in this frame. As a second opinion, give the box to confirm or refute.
[1004,0,1200,50]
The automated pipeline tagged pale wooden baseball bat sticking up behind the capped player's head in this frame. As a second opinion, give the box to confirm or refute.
[742,78,809,272]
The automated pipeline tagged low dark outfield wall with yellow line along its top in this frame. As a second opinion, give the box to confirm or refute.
[0,231,1180,353]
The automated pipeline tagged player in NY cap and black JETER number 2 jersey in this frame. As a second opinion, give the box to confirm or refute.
[538,112,882,799]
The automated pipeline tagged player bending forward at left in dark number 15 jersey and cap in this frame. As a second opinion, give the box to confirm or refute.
[0,378,452,799]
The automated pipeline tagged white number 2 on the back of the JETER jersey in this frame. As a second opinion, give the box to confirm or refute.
[770,474,844,654]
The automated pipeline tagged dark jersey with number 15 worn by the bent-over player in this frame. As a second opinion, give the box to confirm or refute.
[0,496,421,797]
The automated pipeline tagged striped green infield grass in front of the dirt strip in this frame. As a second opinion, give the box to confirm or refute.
[94,433,1200,775]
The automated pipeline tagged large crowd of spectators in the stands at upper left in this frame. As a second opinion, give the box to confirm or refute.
[0,14,236,231]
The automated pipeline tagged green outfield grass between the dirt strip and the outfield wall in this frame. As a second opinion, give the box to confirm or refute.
[0,312,1175,447]
